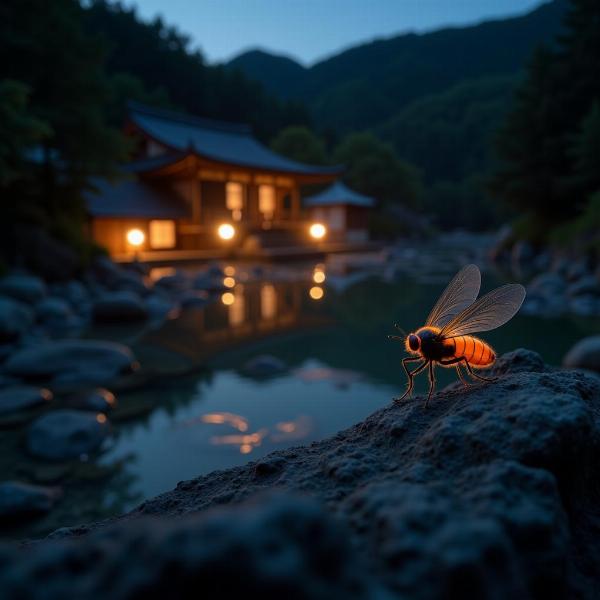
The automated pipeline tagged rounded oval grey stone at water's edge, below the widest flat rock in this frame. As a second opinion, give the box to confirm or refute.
[27,409,110,460]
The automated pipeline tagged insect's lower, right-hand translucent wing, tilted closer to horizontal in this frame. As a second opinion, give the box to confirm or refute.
[440,283,525,337]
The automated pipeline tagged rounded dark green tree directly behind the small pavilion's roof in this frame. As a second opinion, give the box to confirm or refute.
[333,133,422,208]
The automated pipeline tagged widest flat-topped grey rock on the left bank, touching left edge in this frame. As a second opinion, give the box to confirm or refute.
[4,340,137,384]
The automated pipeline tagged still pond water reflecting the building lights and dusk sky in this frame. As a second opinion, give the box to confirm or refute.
[5,246,600,534]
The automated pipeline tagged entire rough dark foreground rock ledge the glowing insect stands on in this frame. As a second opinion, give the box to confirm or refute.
[0,350,600,600]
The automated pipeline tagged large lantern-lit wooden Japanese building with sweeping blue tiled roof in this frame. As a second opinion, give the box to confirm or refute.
[87,104,341,258]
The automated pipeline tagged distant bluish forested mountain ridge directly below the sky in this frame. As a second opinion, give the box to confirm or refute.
[228,0,568,132]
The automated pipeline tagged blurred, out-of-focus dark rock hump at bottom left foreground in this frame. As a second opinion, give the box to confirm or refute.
[0,497,380,600]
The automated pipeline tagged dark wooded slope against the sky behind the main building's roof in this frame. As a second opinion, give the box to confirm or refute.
[85,0,308,139]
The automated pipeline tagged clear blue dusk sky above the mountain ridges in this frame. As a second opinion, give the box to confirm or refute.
[132,0,543,64]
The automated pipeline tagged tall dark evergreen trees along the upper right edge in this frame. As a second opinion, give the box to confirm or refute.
[492,0,600,235]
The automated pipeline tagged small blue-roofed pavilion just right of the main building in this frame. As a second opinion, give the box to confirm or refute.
[304,181,375,243]
